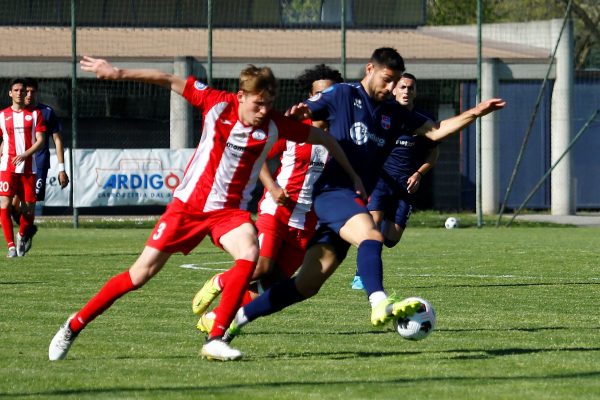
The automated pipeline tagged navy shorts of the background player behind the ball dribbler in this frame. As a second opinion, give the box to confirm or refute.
[367,179,412,228]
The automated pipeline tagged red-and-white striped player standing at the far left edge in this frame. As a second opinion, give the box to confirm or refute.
[0,79,46,258]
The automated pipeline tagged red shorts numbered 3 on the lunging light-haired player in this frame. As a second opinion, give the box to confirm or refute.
[146,199,253,254]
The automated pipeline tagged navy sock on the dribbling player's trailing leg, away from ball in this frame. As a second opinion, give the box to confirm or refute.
[244,278,305,321]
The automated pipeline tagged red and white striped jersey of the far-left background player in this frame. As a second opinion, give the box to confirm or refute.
[0,107,46,174]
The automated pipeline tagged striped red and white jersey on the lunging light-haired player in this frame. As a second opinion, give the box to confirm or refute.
[173,77,309,212]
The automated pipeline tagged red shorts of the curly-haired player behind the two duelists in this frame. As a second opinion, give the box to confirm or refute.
[255,214,314,278]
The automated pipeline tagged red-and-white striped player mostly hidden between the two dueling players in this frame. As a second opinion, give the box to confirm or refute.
[192,64,344,333]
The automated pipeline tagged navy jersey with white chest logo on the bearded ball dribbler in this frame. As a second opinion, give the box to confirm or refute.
[306,83,427,193]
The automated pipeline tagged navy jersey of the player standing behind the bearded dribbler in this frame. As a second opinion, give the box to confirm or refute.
[383,109,438,189]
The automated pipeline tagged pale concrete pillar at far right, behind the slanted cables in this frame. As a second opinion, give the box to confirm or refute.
[550,19,575,215]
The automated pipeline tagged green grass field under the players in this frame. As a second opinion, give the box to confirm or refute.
[0,223,600,400]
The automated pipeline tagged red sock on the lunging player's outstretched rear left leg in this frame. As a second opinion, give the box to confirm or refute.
[69,271,136,333]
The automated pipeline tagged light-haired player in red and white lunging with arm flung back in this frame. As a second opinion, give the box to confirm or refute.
[48,57,364,361]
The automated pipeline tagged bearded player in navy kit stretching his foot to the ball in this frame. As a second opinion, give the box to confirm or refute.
[224,47,505,341]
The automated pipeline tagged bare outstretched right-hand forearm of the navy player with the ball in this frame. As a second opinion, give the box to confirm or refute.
[415,99,506,141]
